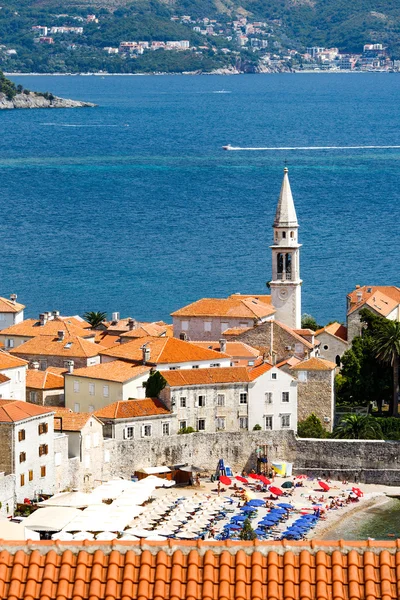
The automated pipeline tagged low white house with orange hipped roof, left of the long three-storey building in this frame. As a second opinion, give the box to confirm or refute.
[95,398,177,441]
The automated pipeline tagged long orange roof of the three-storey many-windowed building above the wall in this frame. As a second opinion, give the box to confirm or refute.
[162,363,272,387]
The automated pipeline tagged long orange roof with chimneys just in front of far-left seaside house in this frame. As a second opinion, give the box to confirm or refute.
[0,317,95,338]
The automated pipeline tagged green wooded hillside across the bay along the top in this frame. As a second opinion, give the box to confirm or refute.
[0,0,400,72]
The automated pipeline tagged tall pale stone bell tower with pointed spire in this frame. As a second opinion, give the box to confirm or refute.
[270,167,302,329]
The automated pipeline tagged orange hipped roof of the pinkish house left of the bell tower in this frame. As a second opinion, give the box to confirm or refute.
[171,295,275,319]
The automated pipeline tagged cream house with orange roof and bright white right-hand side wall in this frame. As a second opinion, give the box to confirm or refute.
[65,360,151,413]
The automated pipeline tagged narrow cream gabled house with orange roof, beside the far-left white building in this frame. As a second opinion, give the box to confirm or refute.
[54,407,104,489]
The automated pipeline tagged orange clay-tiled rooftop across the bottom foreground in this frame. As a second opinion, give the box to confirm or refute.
[0,540,400,600]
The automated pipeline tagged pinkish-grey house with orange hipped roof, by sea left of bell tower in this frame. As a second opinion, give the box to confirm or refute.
[171,294,275,341]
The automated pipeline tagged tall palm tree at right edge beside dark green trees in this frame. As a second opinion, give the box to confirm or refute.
[374,320,400,417]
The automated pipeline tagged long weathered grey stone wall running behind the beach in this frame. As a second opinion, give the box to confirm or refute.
[103,431,400,485]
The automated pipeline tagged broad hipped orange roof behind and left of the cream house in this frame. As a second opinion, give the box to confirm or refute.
[11,335,104,358]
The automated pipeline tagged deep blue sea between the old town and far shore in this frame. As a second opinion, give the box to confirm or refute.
[0,73,400,323]
